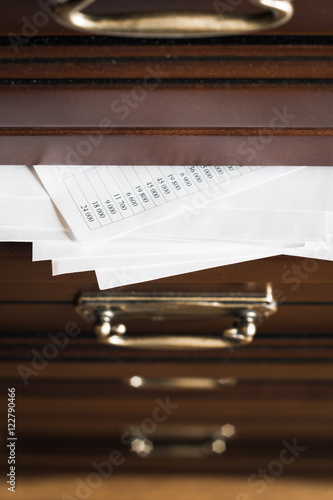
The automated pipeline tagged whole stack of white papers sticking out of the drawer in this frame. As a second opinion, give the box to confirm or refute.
[0,165,333,289]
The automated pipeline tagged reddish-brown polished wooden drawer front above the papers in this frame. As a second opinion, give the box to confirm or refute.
[0,0,333,166]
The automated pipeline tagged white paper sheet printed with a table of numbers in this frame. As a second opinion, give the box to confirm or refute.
[35,166,297,242]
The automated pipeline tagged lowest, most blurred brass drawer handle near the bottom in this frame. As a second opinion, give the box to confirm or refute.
[130,424,235,458]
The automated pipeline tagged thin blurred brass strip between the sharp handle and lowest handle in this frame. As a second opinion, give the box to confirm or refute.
[126,375,237,390]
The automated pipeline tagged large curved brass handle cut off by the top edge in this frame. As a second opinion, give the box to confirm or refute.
[55,0,293,38]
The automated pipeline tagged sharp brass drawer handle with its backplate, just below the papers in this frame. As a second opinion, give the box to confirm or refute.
[77,290,276,350]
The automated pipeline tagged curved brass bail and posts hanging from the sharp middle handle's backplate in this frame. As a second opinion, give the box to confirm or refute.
[95,310,259,350]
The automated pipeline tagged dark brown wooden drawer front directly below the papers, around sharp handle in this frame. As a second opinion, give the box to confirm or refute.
[0,244,333,380]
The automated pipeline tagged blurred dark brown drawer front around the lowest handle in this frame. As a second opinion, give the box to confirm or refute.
[1,378,333,474]
